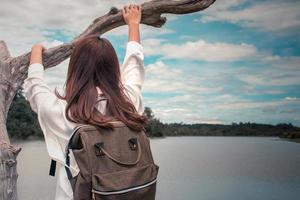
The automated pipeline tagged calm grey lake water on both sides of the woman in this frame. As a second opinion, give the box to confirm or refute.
[12,137,300,200]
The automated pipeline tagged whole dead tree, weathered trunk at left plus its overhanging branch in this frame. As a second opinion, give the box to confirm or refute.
[0,0,215,200]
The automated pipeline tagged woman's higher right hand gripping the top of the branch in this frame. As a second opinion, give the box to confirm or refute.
[122,4,142,26]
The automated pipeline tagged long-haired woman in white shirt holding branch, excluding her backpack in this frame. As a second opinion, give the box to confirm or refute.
[24,4,147,200]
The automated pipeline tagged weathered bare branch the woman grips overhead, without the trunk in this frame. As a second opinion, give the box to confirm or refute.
[12,0,215,72]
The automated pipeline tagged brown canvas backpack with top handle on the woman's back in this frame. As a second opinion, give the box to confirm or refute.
[65,121,159,200]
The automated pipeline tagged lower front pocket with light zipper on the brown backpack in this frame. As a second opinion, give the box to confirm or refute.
[92,163,159,200]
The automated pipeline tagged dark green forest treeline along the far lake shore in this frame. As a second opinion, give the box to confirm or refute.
[7,90,300,139]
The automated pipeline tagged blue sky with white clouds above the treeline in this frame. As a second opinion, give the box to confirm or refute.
[0,0,300,126]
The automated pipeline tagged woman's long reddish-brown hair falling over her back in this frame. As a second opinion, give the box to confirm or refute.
[55,35,147,131]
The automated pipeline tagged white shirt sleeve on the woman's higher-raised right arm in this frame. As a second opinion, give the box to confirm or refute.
[121,41,145,114]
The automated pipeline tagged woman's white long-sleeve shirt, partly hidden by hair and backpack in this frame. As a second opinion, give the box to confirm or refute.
[23,41,145,200]
